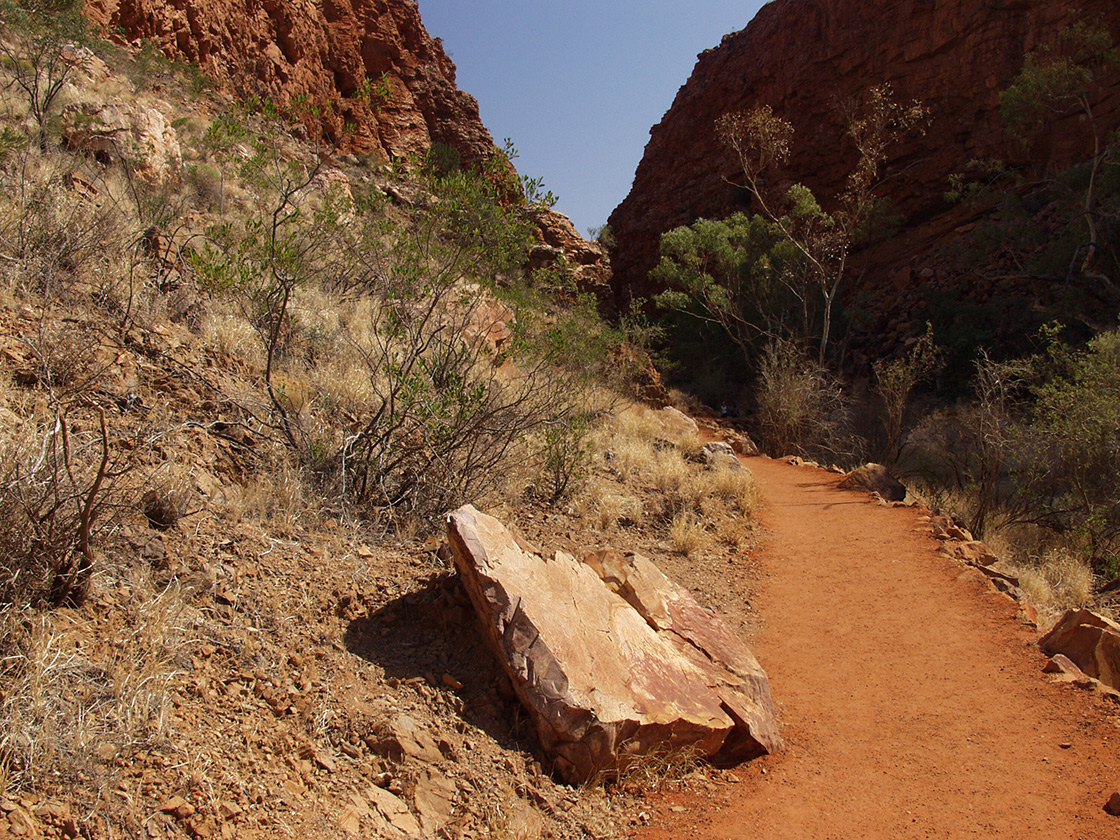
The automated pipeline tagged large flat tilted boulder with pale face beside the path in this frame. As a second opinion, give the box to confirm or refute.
[448,505,781,783]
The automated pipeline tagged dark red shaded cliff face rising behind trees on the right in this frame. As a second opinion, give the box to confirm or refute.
[610,0,1120,338]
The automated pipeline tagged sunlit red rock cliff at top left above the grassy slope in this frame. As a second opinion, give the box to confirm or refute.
[85,0,494,164]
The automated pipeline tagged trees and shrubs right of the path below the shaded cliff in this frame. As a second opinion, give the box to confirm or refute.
[654,22,1120,604]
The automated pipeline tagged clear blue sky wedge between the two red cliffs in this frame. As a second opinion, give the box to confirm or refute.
[419,0,763,235]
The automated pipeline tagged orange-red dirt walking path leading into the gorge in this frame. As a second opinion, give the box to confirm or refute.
[637,458,1120,840]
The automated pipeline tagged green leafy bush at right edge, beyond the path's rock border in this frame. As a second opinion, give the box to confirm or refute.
[903,330,1120,575]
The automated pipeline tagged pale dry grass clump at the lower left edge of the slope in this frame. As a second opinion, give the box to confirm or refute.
[0,581,190,794]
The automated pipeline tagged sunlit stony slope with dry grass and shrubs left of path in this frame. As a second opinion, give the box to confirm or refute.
[0,4,756,838]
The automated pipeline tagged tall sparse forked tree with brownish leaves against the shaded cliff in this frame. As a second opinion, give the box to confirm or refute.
[716,84,927,364]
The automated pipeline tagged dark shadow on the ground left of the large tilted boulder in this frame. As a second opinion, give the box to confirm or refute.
[344,572,542,759]
